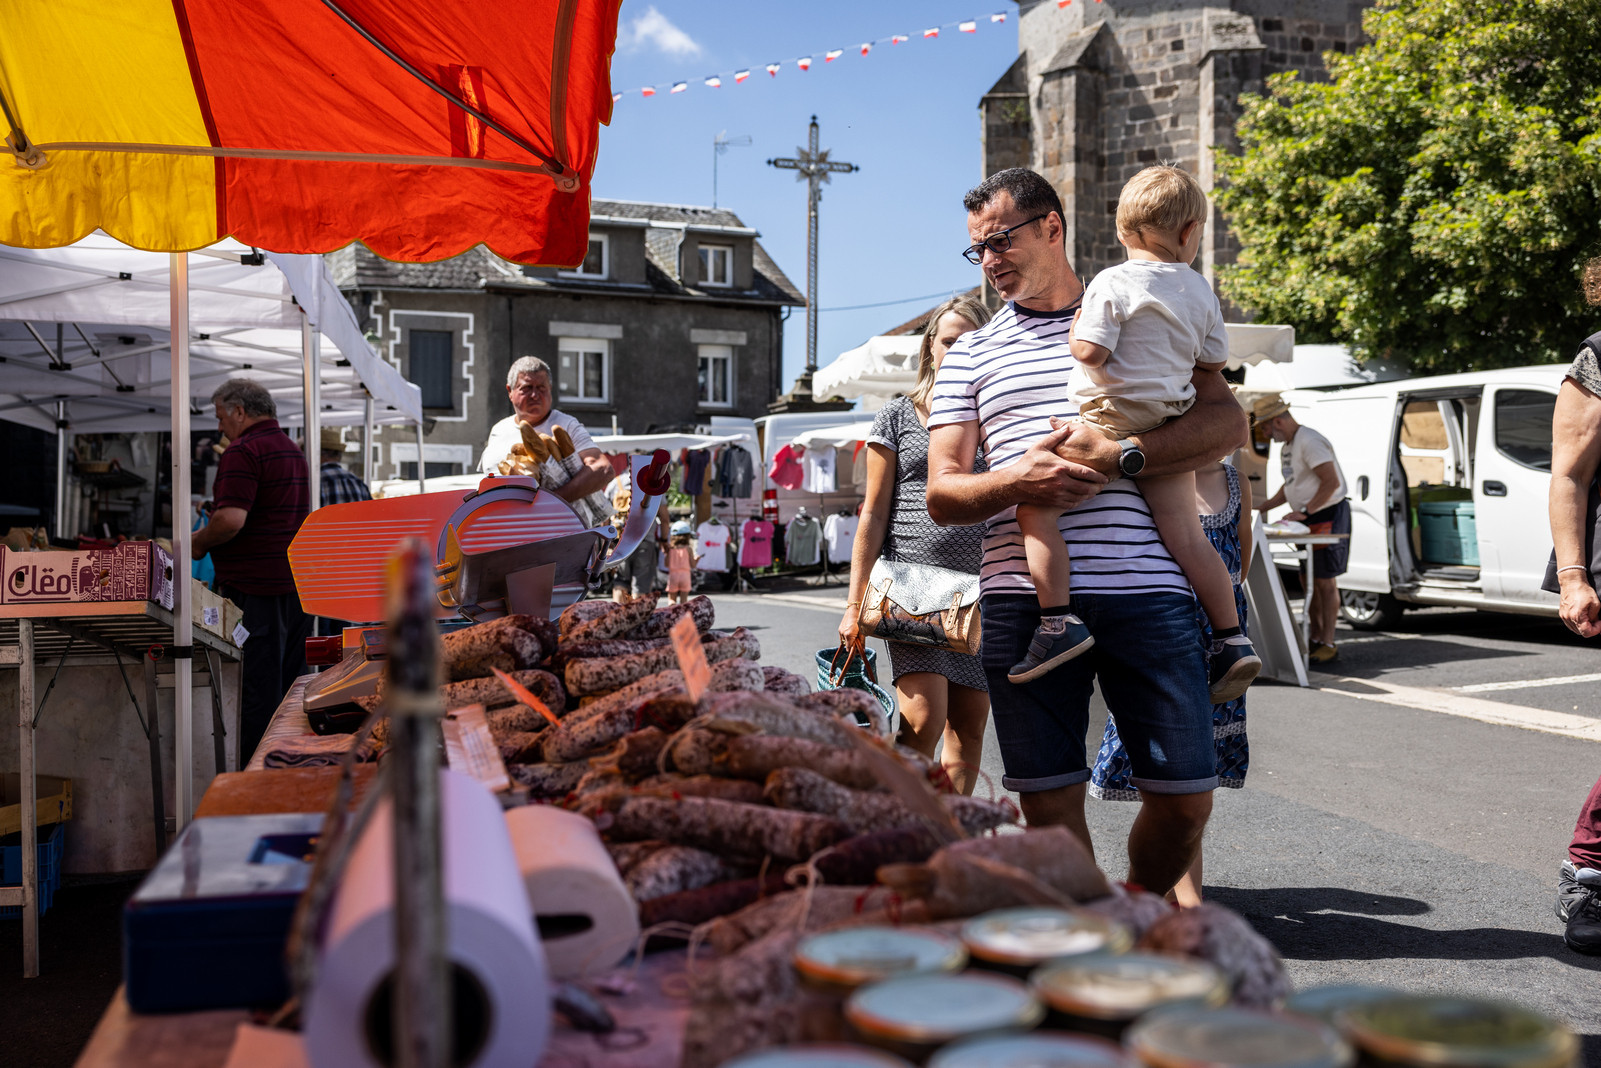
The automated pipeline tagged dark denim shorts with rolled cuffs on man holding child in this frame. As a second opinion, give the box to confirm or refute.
[980,592,1217,794]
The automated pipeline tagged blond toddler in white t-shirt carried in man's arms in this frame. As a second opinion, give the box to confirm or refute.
[1007,163,1262,703]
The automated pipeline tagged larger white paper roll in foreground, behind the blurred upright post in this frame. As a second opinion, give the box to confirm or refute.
[306,770,551,1068]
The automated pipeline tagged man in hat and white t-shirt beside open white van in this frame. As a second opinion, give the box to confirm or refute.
[1250,394,1351,663]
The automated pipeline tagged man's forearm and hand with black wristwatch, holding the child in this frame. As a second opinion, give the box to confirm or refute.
[1050,367,1249,483]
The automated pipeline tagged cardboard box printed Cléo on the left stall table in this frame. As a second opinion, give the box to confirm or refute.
[0,541,173,608]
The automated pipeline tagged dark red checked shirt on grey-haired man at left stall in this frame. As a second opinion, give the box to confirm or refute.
[211,420,311,594]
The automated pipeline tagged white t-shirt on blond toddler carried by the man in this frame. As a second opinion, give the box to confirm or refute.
[1068,259,1228,405]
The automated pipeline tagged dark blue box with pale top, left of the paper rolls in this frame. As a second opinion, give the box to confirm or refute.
[122,813,322,1012]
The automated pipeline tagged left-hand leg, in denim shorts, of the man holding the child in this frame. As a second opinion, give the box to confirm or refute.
[978,594,1095,845]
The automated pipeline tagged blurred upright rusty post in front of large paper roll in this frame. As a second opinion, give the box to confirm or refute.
[386,544,451,1068]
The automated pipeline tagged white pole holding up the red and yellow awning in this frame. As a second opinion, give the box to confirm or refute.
[168,253,195,831]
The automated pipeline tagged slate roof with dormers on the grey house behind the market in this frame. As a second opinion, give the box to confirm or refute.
[327,200,805,306]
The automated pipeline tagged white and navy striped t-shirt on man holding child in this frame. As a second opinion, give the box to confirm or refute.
[929,304,1190,594]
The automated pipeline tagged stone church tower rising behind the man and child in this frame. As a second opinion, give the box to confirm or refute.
[978,0,1372,301]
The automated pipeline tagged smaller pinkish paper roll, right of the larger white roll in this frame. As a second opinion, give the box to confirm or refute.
[506,805,639,978]
